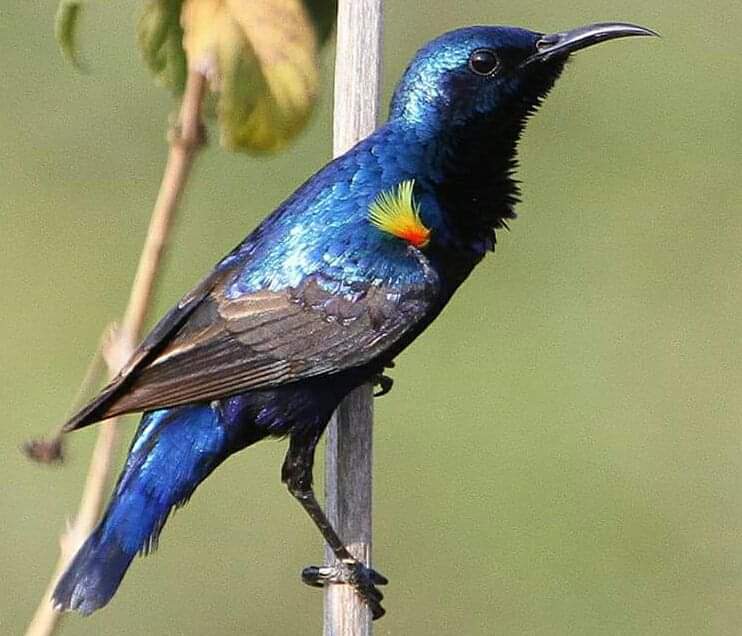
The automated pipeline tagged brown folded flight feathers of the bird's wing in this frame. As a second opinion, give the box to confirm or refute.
[65,252,438,430]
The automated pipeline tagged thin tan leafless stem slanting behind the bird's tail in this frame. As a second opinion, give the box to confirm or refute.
[26,71,205,636]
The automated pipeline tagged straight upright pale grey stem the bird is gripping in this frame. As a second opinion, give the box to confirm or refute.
[324,0,382,636]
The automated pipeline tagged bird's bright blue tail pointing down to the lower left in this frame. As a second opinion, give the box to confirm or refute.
[53,405,229,614]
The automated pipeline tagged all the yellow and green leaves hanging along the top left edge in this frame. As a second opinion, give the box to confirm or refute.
[56,0,337,152]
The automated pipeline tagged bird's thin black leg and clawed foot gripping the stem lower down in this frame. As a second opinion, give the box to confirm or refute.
[281,433,388,620]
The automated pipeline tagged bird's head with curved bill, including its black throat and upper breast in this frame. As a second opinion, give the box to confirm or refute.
[390,23,656,248]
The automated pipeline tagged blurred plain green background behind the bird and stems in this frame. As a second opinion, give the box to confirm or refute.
[0,0,742,635]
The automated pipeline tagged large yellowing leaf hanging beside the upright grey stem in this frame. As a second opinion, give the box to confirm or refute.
[181,0,319,151]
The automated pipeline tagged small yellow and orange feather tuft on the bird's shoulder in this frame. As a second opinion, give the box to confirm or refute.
[368,179,430,247]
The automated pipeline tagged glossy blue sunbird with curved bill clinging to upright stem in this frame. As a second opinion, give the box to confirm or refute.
[53,22,657,618]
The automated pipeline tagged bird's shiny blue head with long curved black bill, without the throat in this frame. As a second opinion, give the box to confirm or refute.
[390,23,655,139]
